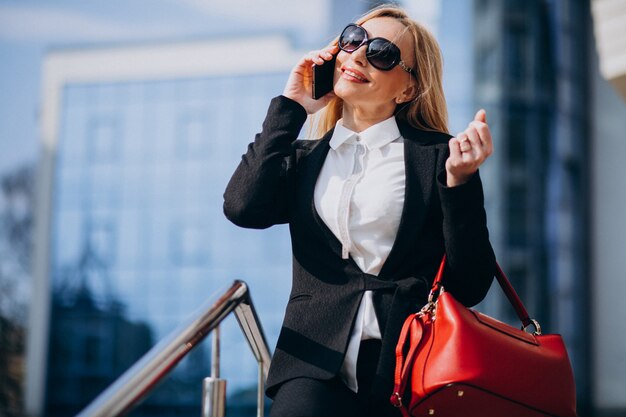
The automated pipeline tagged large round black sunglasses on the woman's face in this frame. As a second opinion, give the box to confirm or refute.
[338,23,414,74]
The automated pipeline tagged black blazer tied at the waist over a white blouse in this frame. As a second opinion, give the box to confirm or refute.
[224,96,495,400]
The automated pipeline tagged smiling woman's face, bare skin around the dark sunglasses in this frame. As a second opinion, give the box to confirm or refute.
[334,17,415,115]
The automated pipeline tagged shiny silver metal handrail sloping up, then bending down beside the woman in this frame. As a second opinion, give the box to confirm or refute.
[78,281,271,417]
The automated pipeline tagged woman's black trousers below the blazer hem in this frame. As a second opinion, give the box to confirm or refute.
[270,340,400,417]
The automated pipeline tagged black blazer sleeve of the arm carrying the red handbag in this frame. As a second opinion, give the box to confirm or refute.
[438,153,496,307]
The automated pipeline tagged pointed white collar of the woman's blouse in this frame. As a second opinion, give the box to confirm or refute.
[330,116,401,149]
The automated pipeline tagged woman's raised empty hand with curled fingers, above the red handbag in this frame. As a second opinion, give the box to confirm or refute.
[446,109,493,187]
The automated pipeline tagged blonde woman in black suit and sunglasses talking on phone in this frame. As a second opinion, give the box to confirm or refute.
[224,6,495,417]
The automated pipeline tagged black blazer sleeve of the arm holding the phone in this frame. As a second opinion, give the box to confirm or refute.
[224,96,307,229]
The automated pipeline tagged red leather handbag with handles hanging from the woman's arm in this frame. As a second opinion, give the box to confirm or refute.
[391,257,576,417]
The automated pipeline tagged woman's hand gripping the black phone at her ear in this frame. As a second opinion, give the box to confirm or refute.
[283,45,339,114]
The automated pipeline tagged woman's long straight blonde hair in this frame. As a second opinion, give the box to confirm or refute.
[312,4,448,137]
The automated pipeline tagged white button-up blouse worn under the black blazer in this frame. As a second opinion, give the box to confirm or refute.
[314,116,405,392]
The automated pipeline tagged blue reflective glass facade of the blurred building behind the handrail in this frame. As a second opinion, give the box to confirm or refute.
[46,73,290,416]
